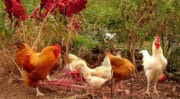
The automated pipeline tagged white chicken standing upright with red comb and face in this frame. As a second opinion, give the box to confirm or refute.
[140,36,167,95]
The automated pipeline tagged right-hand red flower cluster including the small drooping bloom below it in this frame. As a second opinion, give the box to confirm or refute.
[31,0,87,32]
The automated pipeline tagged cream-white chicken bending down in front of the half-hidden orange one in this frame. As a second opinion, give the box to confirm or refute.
[69,54,112,89]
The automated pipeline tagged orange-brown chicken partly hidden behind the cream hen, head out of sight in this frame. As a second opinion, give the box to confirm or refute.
[106,51,135,81]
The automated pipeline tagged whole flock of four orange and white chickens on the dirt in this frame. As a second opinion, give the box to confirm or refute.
[15,36,167,96]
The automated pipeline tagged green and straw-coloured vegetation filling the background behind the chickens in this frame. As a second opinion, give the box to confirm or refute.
[0,0,180,98]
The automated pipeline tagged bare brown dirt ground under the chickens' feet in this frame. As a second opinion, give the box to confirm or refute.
[0,50,180,99]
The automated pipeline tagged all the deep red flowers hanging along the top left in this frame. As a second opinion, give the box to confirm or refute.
[4,0,87,32]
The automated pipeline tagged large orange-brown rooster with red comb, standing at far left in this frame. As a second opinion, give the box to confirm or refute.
[15,42,61,96]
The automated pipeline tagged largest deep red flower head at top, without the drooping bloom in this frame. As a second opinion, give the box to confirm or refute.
[35,0,87,17]
